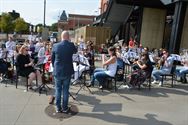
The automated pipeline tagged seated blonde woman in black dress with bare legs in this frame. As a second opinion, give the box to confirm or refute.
[16,45,42,89]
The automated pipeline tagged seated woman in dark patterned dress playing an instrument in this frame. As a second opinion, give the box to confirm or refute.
[130,52,153,86]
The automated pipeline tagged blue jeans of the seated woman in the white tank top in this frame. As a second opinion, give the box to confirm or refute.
[91,68,109,85]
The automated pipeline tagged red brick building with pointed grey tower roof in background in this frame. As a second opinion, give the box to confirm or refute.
[58,11,95,31]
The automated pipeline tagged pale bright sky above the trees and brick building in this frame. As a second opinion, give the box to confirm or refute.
[0,0,100,25]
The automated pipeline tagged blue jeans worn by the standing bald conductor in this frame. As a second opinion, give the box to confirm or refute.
[54,76,71,110]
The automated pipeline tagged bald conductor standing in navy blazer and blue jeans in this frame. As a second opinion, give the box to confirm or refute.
[52,31,77,113]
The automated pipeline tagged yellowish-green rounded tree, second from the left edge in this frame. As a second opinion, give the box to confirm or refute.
[15,18,28,34]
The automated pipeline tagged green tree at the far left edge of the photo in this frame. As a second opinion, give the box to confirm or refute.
[0,13,14,39]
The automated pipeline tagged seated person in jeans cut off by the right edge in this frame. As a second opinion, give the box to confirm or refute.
[176,60,188,83]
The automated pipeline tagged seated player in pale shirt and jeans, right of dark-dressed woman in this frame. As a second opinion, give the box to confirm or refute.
[152,49,174,86]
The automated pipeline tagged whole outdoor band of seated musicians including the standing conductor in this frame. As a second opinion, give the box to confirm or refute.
[0,31,188,113]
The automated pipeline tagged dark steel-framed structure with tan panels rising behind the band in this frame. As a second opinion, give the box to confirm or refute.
[94,0,188,53]
